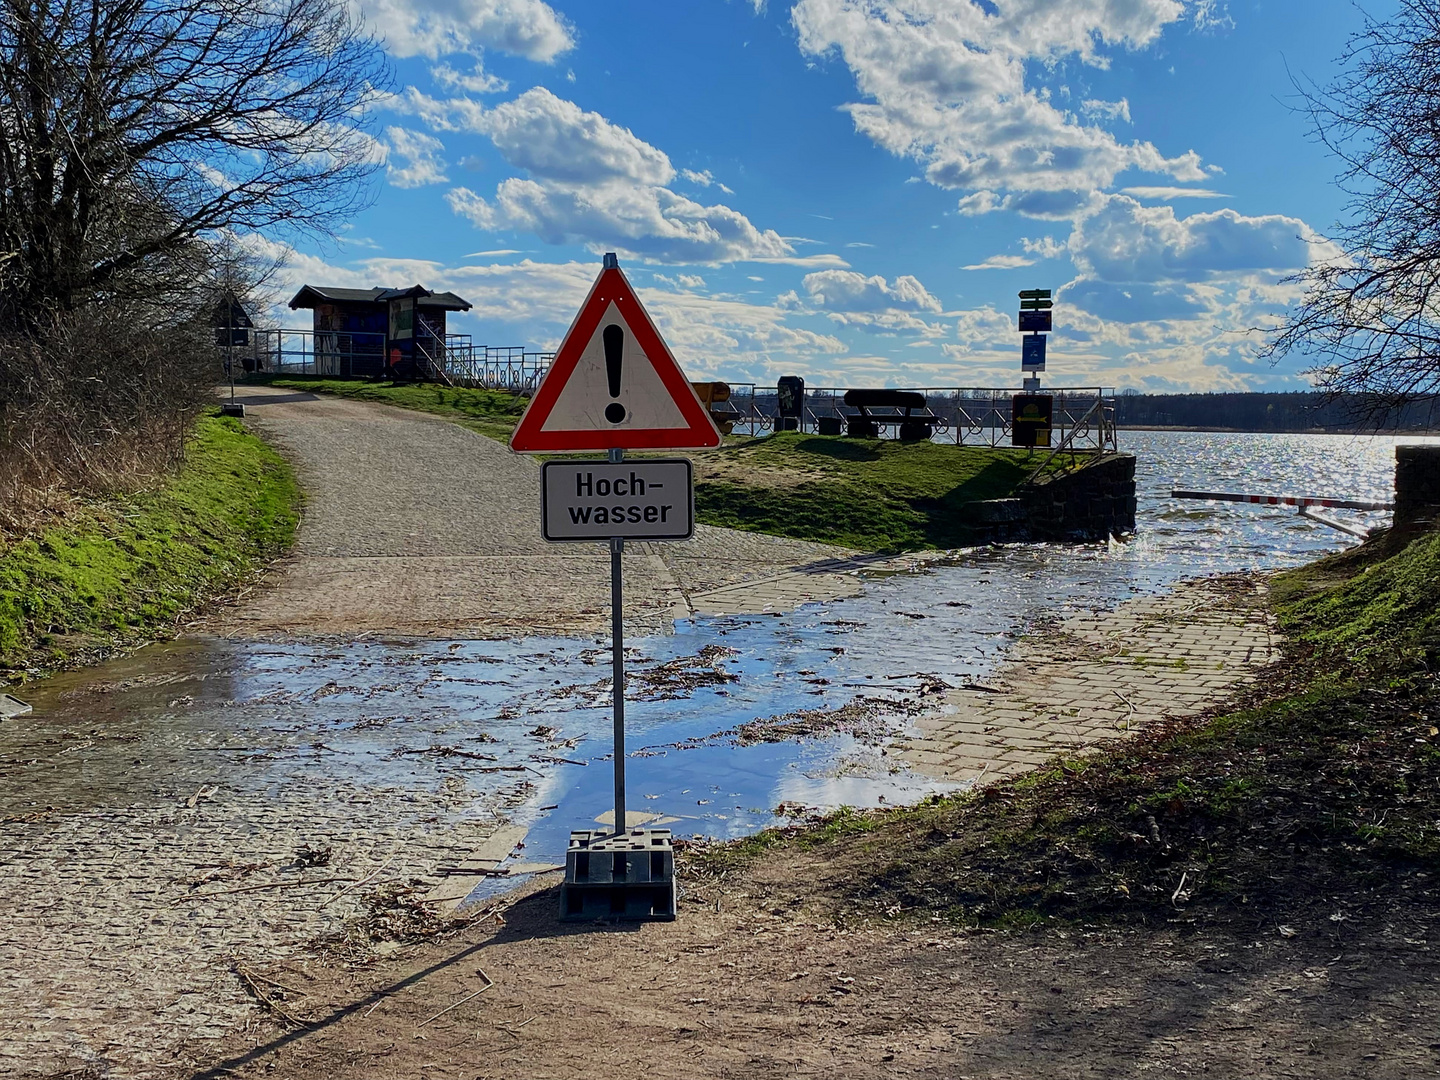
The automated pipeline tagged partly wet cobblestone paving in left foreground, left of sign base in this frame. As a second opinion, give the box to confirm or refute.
[0,641,536,1077]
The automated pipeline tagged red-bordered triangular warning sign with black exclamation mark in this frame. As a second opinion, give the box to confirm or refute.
[510,255,720,454]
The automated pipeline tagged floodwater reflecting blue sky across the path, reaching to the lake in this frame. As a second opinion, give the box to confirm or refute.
[0,432,1434,892]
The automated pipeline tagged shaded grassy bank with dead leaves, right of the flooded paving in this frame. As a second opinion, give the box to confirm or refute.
[691,533,1440,933]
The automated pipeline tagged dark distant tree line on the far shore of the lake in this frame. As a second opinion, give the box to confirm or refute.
[1115,392,1440,432]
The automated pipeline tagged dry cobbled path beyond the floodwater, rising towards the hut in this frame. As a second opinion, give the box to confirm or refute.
[213,387,915,638]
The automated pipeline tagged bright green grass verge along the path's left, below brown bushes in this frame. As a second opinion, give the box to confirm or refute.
[0,416,300,684]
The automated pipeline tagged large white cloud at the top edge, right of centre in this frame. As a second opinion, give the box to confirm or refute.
[792,0,1205,198]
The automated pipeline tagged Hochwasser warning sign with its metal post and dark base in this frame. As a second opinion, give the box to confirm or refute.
[510,253,721,919]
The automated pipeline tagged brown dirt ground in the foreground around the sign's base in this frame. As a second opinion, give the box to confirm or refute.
[192,854,1440,1080]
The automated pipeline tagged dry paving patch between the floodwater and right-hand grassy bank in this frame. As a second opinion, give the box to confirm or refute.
[893,577,1279,782]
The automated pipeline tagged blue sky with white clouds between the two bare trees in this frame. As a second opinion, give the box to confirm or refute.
[262,0,1388,390]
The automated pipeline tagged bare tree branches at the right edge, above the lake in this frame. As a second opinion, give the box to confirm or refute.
[1263,0,1440,420]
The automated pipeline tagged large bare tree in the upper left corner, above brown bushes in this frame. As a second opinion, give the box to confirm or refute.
[0,0,387,331]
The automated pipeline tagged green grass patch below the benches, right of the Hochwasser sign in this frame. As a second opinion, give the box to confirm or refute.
[696,432,1061,552]
